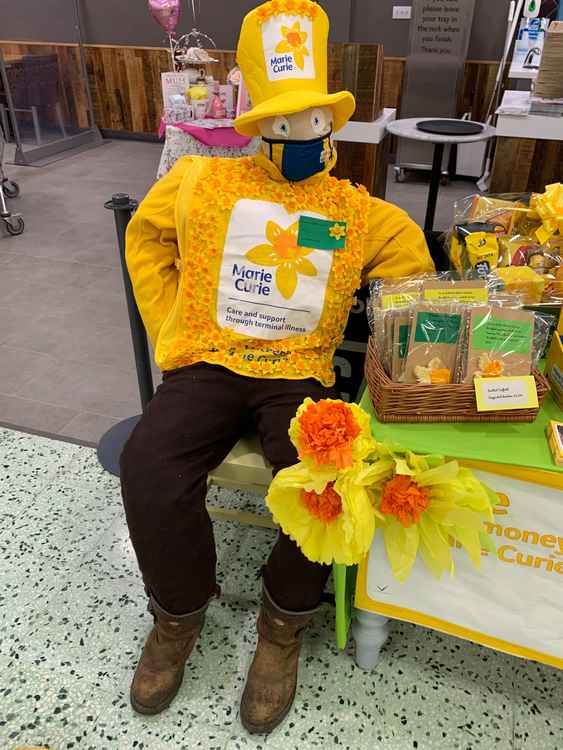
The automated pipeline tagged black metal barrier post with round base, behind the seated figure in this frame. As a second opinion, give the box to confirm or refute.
[98,193,154,476]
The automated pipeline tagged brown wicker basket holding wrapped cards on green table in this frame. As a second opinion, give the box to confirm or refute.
[365,338,549,422]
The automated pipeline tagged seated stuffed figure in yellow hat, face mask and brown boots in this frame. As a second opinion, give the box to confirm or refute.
[121,0,433,733]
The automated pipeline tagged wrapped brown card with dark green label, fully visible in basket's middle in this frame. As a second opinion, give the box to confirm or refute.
[404,304,462,385]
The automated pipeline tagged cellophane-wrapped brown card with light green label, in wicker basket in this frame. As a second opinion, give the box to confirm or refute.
[463,306,535,383]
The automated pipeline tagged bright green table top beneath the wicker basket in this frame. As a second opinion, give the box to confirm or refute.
[360,388,563,474]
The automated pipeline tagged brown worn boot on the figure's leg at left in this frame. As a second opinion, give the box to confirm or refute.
[130,597,215,715]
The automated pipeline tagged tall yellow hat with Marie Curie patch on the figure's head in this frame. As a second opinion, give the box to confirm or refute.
[235,0,356,136]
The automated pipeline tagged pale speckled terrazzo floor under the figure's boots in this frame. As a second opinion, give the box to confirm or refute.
[0,429,563,750]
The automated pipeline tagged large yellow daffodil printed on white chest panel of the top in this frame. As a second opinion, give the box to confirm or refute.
[245,221,317,299]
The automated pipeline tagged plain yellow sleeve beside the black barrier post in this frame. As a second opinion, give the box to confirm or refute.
[125,158,190,346]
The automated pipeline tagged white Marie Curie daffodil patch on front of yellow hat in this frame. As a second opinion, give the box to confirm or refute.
[262,14,315,81]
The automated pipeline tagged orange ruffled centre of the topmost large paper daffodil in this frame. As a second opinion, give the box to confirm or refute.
[299,400,362,469]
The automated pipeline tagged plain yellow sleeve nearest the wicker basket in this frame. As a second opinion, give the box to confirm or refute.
[362,198,435,284]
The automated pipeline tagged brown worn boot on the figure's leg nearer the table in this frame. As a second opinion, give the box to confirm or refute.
[240,587,316,734]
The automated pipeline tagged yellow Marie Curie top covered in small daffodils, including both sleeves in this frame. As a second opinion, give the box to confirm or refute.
[126,154,433,386]
